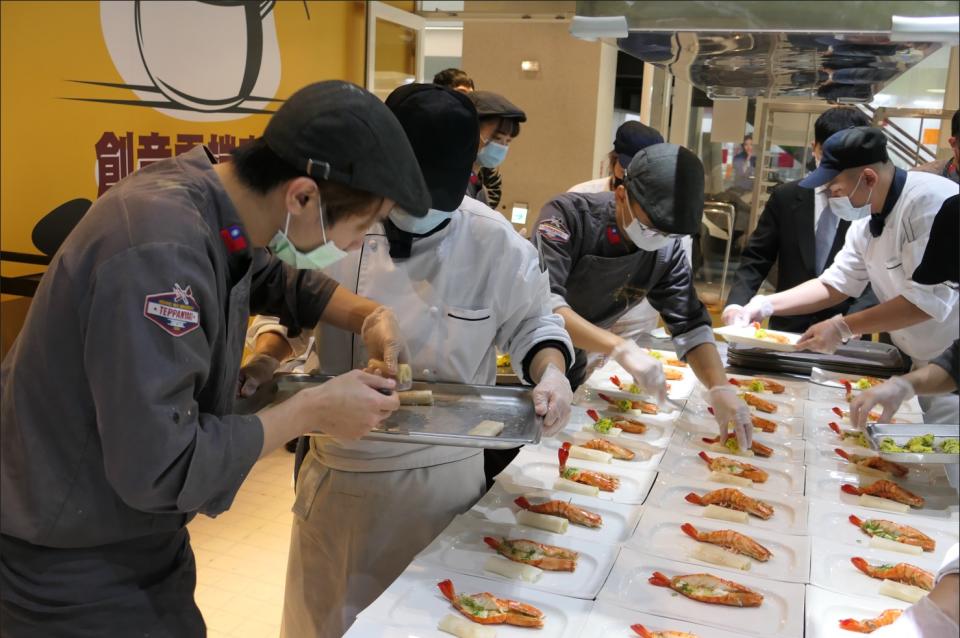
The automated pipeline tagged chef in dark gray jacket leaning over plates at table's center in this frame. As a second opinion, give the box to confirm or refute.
[533,144,752,449]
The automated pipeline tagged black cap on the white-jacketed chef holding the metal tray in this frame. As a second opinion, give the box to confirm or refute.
[386,84,480,211]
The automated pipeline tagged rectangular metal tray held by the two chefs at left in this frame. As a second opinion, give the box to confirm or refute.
[236,374,543,449]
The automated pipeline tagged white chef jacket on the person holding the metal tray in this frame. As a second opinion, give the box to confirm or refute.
[251,197,574,472]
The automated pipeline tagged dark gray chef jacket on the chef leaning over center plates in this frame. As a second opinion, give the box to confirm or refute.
[531,192,714,385]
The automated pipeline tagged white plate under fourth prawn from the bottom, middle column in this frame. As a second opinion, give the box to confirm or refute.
[647,473,807,535]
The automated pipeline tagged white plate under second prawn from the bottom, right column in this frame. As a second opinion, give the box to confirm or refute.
[810,536,940,601]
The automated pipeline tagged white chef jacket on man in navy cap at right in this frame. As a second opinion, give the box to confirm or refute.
[820,172,960,362]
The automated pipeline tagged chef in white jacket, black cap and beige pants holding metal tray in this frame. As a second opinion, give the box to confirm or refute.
[244,84,573,638]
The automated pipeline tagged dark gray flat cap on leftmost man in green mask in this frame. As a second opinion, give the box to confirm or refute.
[263,80,430,217]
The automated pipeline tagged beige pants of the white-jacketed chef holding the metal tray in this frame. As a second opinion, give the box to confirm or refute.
[280,451,486,638]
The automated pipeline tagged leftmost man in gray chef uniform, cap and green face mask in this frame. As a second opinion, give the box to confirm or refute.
[0,82,430,638]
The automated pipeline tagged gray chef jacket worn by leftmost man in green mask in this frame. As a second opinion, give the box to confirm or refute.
[0,147,336,548]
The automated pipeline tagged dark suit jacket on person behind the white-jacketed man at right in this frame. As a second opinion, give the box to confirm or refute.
[727,182,877,333]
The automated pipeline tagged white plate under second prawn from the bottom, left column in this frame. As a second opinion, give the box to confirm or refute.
[416,515,620,600]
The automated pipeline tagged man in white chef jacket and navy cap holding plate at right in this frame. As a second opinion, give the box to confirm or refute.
[741,126,960,423]
